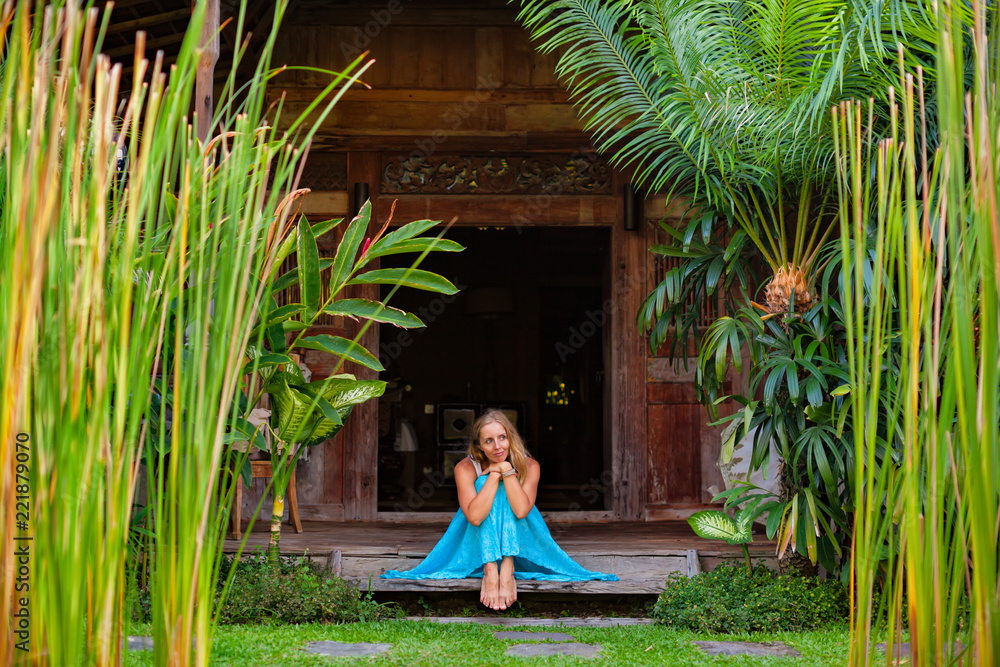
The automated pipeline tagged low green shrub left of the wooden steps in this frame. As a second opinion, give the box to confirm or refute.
[132,553,400,624]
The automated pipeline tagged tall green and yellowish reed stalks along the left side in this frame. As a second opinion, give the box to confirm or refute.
[0,2,364,665]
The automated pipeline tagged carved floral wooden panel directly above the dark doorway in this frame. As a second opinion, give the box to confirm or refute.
[381,154,611,195]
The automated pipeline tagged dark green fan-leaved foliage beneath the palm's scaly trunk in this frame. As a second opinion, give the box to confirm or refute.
[697,282,884,573]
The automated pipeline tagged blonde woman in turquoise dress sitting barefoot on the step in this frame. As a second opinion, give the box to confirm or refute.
[382,410,618,610]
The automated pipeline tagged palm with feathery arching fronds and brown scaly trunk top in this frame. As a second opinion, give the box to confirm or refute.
[519,0,935,320]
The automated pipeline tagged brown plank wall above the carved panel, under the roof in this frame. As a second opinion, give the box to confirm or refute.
[276,0,589,155]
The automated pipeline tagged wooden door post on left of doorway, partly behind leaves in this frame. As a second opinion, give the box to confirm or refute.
[343,152,379,521]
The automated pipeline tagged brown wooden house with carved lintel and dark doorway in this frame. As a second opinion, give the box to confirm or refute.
[112,0,764,596]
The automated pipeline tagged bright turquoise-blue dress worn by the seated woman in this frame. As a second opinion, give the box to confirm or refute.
[382,466,618,581]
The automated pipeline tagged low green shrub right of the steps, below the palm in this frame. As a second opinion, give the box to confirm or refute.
[652,565,848,633]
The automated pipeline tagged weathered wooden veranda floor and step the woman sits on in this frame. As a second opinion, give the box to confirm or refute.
[225,520,776,595]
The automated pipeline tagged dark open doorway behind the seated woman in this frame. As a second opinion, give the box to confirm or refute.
[378,227,610,512]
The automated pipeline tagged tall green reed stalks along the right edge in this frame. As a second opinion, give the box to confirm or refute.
[834,0,1000,665]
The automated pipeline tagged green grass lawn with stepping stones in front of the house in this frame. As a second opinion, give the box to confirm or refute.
[125,621,848,667]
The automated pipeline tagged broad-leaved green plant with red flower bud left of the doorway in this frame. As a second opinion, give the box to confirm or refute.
[242,202,463,456]
